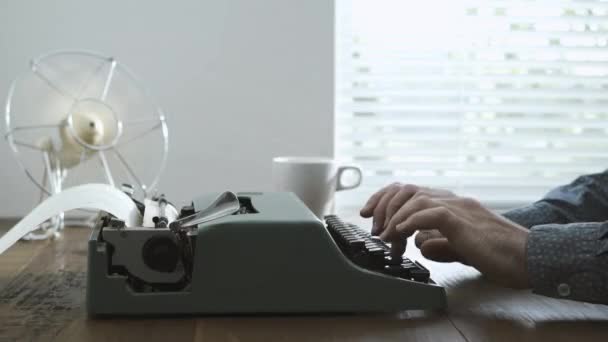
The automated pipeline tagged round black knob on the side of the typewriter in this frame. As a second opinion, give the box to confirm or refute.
[142,236,179,273]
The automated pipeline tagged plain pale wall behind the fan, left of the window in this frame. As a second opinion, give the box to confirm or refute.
[0,0,333,216]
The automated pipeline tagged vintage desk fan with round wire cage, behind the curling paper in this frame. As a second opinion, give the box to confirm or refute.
[5,51,168,239]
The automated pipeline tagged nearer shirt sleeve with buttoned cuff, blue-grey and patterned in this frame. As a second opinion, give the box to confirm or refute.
[526,222,608,304]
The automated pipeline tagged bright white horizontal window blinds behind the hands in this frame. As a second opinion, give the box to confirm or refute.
[335,0,608,209]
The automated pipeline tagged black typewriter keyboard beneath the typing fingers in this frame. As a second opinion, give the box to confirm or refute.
[325,215,430,283]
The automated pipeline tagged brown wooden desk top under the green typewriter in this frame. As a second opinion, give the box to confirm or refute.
[0,219,608,342]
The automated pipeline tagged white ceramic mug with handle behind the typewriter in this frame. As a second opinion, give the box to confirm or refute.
[272,157,363,219]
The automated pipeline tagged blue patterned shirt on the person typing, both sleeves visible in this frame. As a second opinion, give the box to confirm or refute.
[504,170,608,304]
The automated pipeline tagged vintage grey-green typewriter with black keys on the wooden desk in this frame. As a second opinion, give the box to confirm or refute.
[87,193,446,315]
